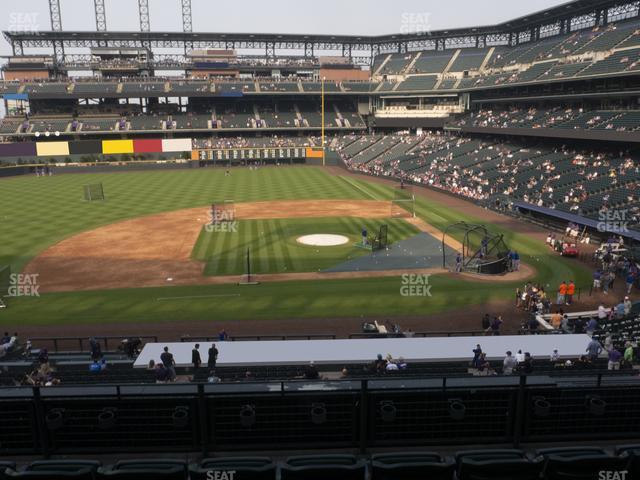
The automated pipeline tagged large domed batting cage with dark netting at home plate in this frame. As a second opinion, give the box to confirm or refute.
[442,222,509,275]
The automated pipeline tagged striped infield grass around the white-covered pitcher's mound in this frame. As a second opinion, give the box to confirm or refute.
[192,217,418,276]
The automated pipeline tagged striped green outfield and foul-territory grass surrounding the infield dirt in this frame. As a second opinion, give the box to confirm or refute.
[0,167,590,329]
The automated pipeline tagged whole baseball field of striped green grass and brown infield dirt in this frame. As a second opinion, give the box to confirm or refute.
[0,166,590,335]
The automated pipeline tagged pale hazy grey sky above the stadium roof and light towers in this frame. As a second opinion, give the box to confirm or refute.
[0,0,567,55]
